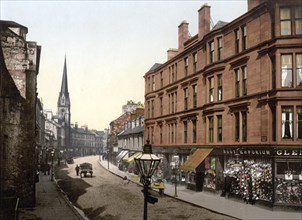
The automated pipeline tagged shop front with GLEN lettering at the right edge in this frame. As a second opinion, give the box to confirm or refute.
[274,148,302,206]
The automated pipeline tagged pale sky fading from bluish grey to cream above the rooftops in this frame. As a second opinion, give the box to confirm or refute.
[0,0,247,130]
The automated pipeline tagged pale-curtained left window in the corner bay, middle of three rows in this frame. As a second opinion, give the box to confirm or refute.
[281,55,293,87]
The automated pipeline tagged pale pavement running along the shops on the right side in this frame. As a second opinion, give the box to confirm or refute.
[99,160,302,220]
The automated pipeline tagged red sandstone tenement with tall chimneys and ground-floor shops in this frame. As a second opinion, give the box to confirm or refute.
[144,0,302,205]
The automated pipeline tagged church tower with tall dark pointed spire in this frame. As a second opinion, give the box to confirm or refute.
[57,56,71,149]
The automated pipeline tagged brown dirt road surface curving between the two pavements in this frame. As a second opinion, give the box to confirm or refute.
[56,156,234,220]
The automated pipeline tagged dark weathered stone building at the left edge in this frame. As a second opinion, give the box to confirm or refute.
[0,21,41,207]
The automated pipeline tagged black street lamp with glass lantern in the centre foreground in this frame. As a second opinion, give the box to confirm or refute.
[134,141,160,220]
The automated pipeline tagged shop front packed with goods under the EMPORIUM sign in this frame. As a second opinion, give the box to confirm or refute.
[222,147,273,204]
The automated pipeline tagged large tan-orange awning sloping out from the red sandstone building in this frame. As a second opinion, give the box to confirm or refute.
[179,148,213,172]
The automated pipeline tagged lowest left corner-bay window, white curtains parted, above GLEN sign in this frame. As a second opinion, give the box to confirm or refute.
[282,107,293,139]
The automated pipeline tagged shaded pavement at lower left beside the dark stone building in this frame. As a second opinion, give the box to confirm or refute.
[19,174,85,220]
